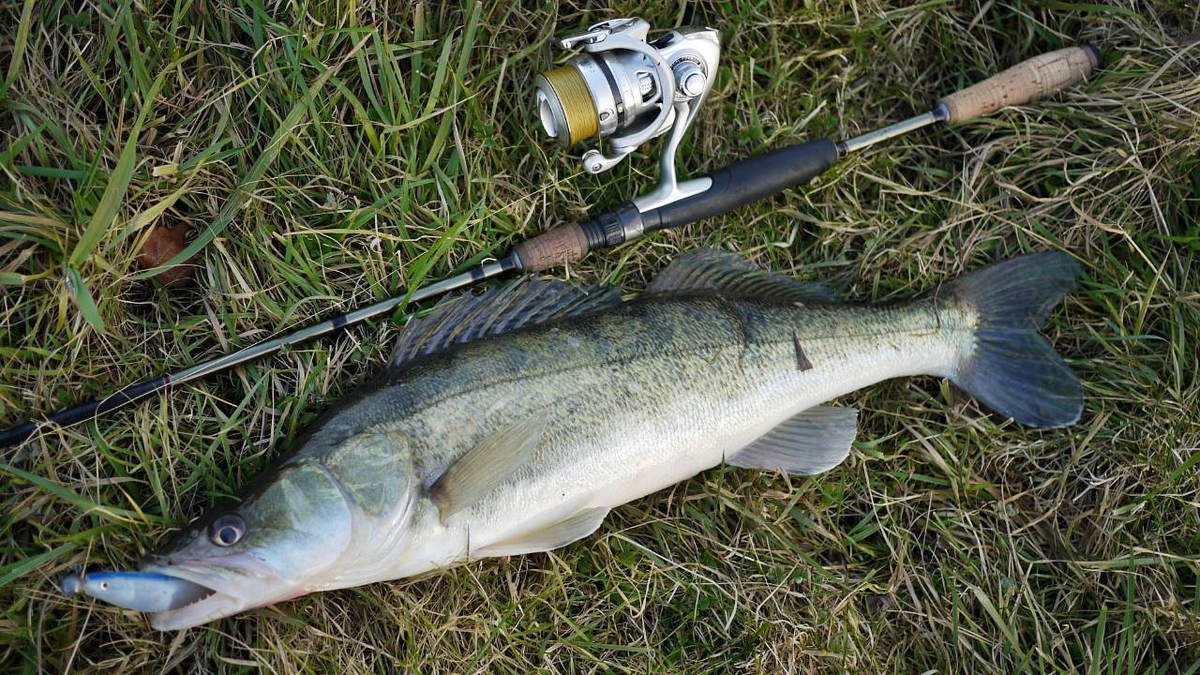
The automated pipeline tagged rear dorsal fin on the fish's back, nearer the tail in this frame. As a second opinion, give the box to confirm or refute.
[646,249,839,305]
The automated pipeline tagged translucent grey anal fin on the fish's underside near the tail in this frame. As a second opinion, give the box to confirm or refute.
[725,406,858,476]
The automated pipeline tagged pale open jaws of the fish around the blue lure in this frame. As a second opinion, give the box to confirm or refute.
[142,556,286,631]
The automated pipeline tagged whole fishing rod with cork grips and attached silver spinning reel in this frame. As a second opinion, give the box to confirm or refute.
[0,18,1100,447]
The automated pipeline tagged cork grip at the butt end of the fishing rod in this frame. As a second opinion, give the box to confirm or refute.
[940,44,1100,123]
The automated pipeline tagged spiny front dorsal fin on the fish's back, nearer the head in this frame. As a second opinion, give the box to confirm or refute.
[391,279,622,366]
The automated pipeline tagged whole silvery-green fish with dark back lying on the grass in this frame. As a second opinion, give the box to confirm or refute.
[65,249,1084,631]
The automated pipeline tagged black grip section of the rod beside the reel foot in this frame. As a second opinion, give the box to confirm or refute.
[642,138,839,232]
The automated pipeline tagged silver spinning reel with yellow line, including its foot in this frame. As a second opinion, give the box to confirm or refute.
[535,18,721,210]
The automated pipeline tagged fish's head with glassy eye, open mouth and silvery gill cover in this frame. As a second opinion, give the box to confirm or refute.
[142,461,354,631]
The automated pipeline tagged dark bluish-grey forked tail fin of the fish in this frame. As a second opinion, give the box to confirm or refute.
[937,252,1084,428]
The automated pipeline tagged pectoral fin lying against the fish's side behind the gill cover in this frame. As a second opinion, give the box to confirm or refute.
[428,414,546,522]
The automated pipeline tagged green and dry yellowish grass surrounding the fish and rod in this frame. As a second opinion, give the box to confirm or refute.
[0,0,1200,675]
